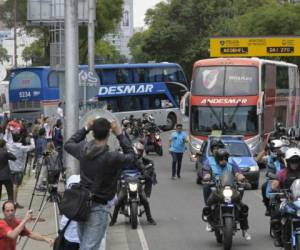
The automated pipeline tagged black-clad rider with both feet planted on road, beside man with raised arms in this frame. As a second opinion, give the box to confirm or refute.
[109,142,156,226]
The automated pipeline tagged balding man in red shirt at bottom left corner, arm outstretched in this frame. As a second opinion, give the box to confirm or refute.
[0,201,53,250]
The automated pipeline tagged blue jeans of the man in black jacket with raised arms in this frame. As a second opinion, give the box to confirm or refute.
[78,202,108,250]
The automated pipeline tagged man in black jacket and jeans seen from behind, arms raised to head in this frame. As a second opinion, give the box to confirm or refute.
[64,118,135,250]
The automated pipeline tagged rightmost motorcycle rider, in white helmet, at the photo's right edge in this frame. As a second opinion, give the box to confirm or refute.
[271,148,300,246]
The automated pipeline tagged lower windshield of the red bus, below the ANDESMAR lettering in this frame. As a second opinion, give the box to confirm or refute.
[191,106,258,135]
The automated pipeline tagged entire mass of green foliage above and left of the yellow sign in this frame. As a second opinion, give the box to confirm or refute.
[129,0,300,76]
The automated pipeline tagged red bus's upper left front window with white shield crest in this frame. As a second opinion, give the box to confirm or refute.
[192,66,225,96]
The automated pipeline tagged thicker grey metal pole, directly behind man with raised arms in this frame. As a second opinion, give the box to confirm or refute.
[64,0,79,176]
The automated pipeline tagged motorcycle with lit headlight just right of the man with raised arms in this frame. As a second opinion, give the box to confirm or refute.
[120,170,145,229]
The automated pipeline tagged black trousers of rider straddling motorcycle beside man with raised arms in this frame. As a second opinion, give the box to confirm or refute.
[111,187,152,222]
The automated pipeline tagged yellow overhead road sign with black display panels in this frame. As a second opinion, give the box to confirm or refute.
[210,36,300,57]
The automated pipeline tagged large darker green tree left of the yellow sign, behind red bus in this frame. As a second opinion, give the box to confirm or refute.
[130,0,282,75]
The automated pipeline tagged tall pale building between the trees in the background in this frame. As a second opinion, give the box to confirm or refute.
[105,0,133,59]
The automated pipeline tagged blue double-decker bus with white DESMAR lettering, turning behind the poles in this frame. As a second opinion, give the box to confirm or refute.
[9,63,189,129]
